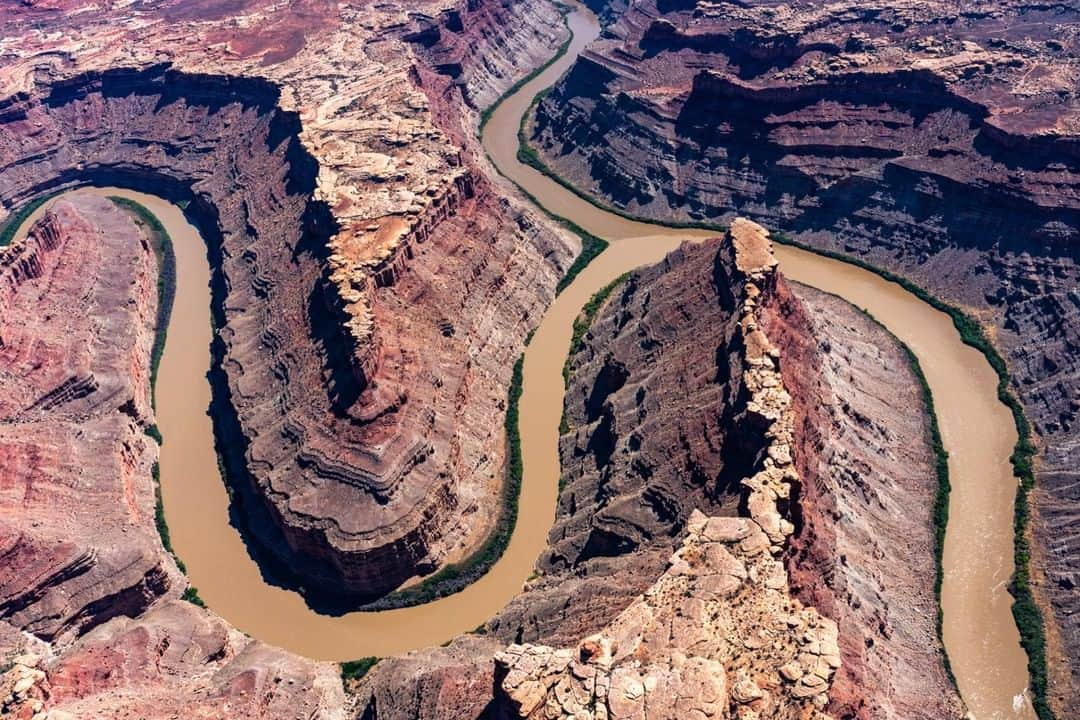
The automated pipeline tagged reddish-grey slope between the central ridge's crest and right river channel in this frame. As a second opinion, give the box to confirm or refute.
[765,285,962,720]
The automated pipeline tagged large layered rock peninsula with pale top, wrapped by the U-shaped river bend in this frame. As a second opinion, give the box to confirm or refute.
[0,4,573,603]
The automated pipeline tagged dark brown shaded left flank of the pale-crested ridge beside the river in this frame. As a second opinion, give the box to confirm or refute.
[492,221,794,642]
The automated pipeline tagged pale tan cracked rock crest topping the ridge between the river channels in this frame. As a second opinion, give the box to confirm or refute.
[496,219,840,719]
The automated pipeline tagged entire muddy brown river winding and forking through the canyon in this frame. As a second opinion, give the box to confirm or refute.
[8,4,1035,720]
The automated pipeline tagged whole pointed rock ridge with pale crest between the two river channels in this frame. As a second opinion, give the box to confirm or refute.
[360,221,960,719]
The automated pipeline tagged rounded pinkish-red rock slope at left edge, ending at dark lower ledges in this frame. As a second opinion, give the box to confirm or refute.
[0,198,168,639]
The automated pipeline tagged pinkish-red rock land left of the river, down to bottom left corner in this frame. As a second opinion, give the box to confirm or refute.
[0,199,342,720]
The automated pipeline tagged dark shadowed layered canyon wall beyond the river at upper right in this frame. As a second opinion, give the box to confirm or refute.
[532,0,1080,716]
